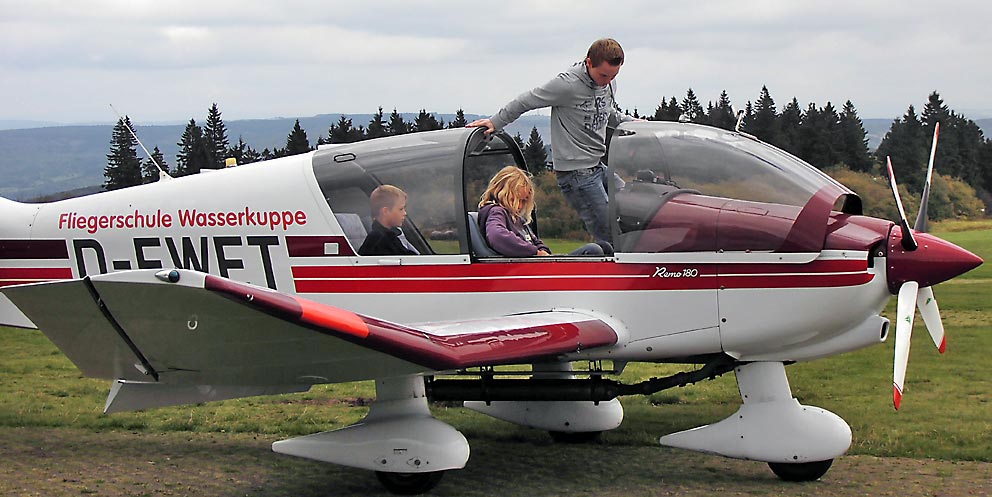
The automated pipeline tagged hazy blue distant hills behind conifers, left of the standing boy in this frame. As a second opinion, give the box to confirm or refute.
[0,113,550,200]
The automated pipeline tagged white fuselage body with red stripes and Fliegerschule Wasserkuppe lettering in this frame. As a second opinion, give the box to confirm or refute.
[0,153,890,361]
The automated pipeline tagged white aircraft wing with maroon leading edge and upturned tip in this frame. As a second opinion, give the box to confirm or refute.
[0,269,618,392]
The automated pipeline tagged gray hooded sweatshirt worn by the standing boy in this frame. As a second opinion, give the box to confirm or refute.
[490,62,633,171]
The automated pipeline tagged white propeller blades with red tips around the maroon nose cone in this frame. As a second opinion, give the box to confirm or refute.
[885,123,947,410]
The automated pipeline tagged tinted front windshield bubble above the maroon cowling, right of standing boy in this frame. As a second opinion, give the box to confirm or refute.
[610,122,854,252]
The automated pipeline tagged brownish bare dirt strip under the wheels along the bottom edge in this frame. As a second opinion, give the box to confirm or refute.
[0,428,992,497]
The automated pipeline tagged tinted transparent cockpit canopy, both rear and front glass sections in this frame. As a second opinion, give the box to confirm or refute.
[313,122,861,257]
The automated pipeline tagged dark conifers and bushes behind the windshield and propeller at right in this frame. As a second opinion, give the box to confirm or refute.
[633,87,992,217]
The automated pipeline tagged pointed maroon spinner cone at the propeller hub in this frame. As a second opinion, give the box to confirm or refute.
[887,229,984,295]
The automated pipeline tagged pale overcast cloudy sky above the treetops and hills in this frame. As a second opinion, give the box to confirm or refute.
[0,0,992,124]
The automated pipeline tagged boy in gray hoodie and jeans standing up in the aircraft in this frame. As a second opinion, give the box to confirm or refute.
[468,38,633,247]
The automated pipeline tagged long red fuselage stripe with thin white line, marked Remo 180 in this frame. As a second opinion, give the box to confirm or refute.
[292,260,874,293]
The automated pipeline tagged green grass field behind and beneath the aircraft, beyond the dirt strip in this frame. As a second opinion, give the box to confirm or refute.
[0,221,992,492]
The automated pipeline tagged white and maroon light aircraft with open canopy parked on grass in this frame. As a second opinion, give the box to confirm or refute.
[0,122,982,493]
